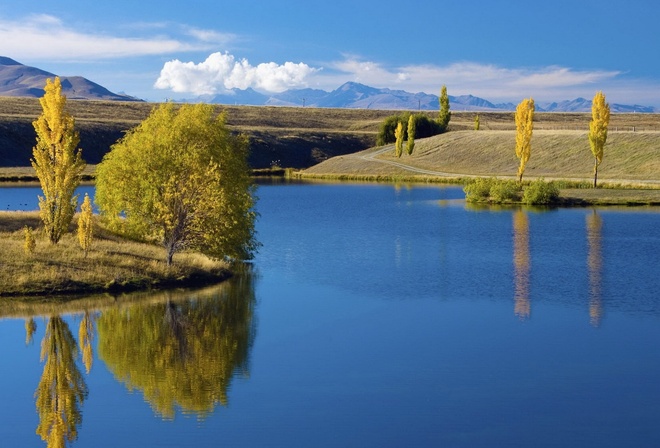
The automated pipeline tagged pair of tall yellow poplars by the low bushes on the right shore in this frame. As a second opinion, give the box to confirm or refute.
[515,91,610,188]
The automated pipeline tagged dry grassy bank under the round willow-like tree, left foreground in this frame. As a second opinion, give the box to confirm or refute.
[0,212,231,296]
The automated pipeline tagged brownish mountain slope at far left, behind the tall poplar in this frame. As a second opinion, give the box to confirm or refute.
[0,56,141,101]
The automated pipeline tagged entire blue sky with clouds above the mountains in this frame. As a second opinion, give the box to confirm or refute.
[0,0,660,107]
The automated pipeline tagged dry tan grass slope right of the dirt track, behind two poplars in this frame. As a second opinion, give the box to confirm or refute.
[379,131,660,180]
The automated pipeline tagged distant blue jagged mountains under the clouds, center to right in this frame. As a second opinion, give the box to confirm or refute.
[192,82,658,113]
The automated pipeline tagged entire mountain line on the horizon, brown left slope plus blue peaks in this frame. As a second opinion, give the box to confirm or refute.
[0,56,660,113]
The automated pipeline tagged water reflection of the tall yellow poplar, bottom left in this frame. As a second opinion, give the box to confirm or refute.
[35,316,87,448]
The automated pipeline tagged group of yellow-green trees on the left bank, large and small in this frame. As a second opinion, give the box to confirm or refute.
[26,78,258,265]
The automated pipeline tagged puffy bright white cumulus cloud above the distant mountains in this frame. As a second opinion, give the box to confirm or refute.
[154,52,319,95]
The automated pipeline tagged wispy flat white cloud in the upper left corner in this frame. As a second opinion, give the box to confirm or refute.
[0,14,217,60]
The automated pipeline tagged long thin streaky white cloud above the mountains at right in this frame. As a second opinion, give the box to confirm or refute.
[309,55,660,104]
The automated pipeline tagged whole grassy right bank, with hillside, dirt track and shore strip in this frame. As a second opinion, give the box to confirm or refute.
[297,124,660,205]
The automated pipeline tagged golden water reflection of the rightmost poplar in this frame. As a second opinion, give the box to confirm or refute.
[586,209,603,327]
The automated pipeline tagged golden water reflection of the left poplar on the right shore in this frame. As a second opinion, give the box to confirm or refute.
[513,210,531,320]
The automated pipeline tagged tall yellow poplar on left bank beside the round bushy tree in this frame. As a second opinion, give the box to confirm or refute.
[31,77,85,244]
